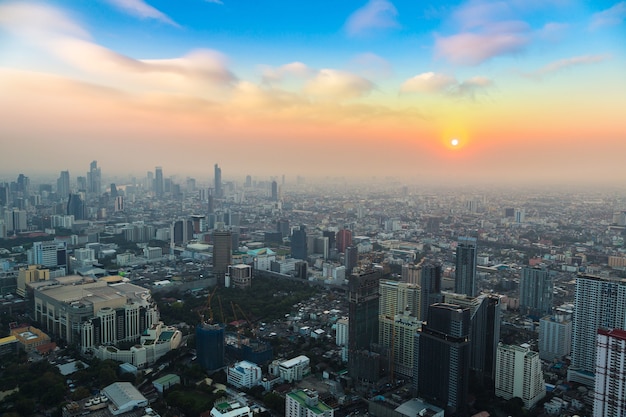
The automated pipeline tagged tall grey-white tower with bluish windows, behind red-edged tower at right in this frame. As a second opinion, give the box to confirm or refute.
[567,275,626,387]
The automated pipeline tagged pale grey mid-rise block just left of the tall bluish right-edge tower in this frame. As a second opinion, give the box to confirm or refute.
[539,308,572,362]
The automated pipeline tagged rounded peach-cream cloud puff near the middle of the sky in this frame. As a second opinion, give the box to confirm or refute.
[304,69,374,99]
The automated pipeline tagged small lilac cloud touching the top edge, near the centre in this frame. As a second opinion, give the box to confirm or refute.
[345,0,399,36]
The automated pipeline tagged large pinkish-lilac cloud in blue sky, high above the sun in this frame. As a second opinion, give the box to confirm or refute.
[435,21,530,66]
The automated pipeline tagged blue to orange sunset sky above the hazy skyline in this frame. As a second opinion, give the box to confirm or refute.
[0,0,626,185]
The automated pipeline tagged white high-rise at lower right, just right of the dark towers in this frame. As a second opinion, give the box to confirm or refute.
[496,343,546,409]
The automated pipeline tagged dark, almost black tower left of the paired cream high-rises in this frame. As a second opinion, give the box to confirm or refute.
[348,270,381,381]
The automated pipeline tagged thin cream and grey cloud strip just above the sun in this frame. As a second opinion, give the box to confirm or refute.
[400,72,493,99]
